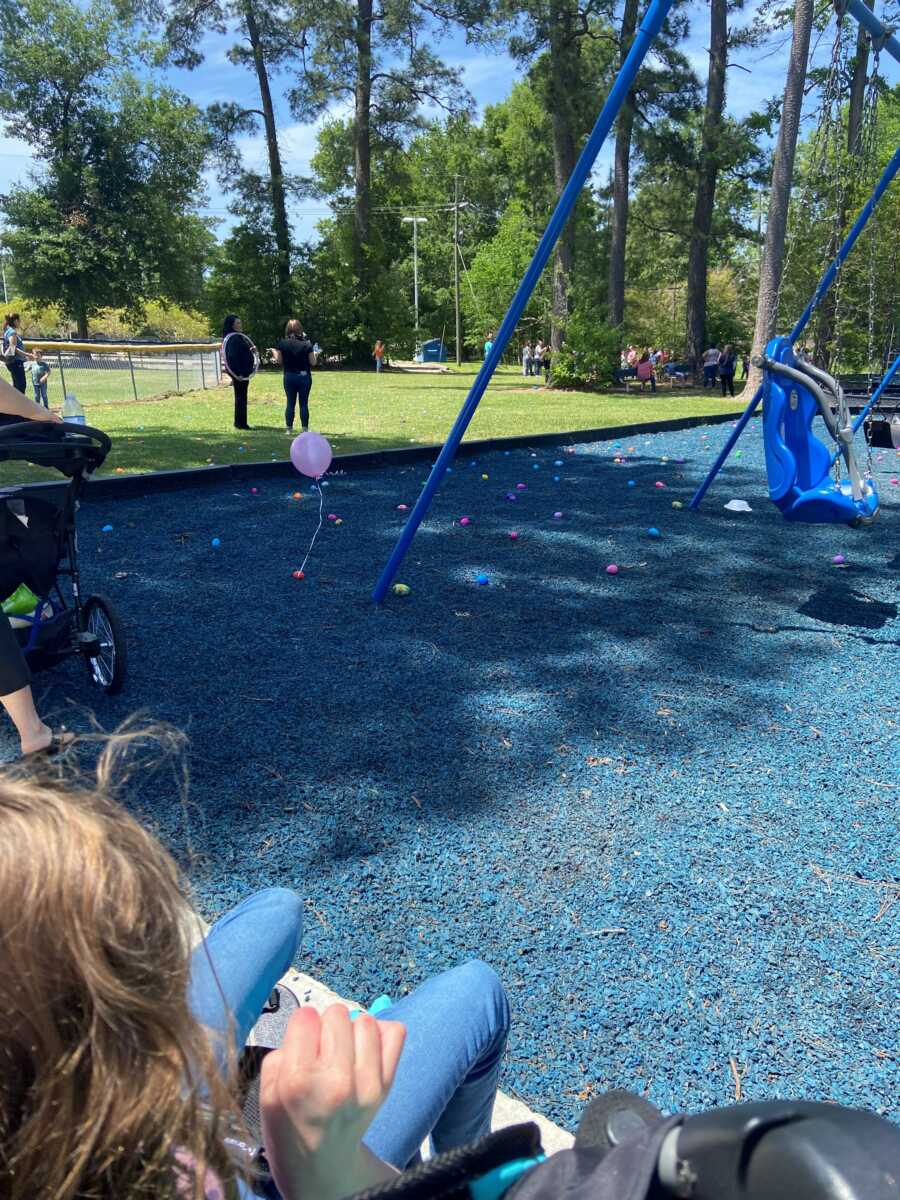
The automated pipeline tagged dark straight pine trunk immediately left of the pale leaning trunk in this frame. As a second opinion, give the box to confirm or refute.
[688,0,728,367]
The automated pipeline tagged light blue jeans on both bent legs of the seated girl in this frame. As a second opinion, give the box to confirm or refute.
[188,888,509,1166]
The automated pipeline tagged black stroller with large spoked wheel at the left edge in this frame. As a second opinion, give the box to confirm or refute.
[0,421,127,695]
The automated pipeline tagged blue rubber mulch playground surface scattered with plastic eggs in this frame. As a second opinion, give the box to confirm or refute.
[6,427,900,1128]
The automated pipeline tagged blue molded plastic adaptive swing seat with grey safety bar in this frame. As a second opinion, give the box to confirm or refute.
[763,337,878,526]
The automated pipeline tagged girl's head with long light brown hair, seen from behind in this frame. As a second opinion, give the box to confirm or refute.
[0,738,243,1200]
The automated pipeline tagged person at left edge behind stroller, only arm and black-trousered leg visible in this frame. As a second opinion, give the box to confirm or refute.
[0,379,72,755]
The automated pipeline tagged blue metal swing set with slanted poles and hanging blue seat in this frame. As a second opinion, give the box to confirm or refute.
[372,0,900,602]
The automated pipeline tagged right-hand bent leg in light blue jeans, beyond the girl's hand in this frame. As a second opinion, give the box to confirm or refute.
[362,960,509,1166]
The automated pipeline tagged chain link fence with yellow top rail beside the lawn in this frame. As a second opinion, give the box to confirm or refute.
[25,342,222,407]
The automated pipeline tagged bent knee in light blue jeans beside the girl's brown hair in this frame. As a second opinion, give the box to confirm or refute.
[187,888,304,1069]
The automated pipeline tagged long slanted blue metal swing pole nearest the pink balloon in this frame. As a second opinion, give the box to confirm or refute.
[372,0,674,602]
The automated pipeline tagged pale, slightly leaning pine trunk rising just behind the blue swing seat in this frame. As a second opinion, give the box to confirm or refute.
[744,0,812,396]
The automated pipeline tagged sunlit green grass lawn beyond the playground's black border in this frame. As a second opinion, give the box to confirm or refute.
[0,366,742,482]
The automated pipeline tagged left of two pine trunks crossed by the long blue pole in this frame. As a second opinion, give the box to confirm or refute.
[550,0,578,353]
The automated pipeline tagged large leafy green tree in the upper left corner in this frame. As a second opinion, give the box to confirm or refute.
[0,0,211,336]
